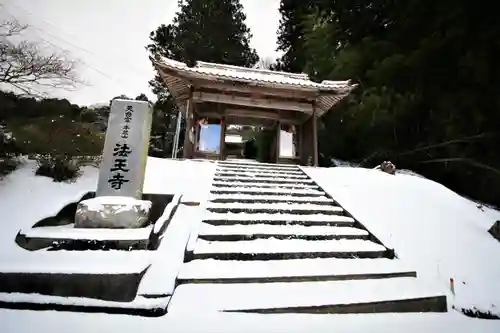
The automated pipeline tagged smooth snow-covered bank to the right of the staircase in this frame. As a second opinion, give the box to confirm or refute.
[302,167,500,314]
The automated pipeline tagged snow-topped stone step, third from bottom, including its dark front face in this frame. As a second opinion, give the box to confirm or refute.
[192,238,388,260]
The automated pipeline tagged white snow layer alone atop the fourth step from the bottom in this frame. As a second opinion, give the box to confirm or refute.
[199,223,368,236]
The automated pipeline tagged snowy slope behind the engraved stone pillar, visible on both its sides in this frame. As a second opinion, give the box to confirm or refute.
[0,157,215,253]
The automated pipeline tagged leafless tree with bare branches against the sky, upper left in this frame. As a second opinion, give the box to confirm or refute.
[0,20,78,94]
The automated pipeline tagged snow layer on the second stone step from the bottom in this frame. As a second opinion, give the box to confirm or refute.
[179,258,411,279]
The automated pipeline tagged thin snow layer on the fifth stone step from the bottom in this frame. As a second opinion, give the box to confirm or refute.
[204,213,354,223]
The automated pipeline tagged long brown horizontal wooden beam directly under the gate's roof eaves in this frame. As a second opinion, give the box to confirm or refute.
[193,91,313,114]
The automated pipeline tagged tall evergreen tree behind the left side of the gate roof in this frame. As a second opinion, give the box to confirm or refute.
[147,0,259,156]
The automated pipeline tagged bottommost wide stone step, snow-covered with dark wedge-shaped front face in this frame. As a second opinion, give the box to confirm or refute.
[168,277,447,314]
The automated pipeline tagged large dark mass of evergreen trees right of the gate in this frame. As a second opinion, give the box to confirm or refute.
[279,0,500,204]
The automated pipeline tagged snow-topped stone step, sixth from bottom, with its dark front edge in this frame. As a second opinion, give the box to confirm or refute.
[206,202,344,215]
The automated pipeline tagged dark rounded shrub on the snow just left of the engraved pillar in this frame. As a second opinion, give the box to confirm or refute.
[35,154,81,182]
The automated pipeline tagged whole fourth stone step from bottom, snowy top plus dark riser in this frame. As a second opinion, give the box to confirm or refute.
[198,223,369,241]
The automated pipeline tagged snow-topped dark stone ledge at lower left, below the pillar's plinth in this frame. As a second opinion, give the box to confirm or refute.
[0,250,153,302]
